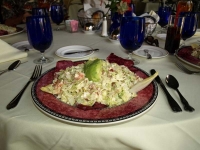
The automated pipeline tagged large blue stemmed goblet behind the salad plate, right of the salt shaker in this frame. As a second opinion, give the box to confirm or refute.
[119,16,145,64]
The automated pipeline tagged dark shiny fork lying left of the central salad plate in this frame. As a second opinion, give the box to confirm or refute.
[6,65,42,109]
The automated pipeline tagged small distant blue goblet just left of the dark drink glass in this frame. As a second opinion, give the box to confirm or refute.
[158,6,171,33]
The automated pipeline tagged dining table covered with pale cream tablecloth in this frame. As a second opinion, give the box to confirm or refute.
[0,23,200,150]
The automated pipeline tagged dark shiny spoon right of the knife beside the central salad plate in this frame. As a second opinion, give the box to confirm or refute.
[165,75,195,112]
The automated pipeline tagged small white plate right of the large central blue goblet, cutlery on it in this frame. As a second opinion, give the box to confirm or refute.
[133,45,169,58]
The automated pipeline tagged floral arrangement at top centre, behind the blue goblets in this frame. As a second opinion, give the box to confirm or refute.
[102,0,131,15]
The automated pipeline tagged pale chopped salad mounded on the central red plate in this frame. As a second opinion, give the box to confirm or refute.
[41,60,143,107]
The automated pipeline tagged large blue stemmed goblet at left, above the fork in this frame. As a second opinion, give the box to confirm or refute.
[26,16,53,64]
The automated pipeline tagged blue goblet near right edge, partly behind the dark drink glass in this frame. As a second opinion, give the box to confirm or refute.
[180,12,198,46]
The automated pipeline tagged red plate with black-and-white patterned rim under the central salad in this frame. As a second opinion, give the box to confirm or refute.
[31,62,158,125]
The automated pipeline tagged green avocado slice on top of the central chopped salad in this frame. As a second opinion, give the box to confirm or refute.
[84,59,103,82]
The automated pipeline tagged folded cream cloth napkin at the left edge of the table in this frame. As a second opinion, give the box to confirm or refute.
[0,39,27,63]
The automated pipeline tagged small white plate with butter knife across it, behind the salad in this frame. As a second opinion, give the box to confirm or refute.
[55,45,94,59]
